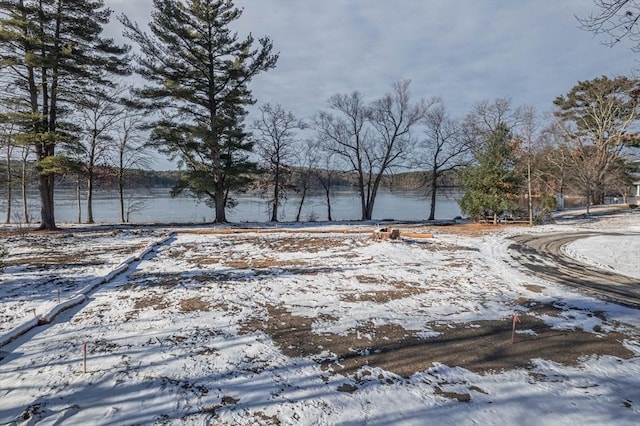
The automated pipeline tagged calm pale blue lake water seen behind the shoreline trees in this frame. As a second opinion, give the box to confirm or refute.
[0,188,461,223]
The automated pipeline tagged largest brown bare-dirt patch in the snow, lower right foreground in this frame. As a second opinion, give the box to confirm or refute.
[242,304,634,377]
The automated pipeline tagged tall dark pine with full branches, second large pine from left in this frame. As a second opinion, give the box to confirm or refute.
[121,0,278,222]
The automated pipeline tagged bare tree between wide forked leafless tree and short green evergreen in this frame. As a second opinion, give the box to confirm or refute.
[416,101,471,220]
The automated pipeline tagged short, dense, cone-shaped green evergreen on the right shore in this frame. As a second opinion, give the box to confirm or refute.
[459,123,521,223]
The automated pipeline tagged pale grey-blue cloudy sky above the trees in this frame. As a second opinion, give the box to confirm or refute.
[105,0,640,168]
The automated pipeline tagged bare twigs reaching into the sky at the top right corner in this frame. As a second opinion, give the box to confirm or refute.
[577,0,640,52]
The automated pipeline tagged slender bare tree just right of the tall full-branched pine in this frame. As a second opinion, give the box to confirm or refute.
[253,103,306,222]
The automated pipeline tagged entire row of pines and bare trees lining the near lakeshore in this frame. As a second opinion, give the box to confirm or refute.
[0,0,640,229]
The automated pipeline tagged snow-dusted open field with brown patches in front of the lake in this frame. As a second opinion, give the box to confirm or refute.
[0,211,640,425]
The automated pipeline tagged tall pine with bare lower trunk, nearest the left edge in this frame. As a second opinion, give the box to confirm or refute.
[0,0,127,229]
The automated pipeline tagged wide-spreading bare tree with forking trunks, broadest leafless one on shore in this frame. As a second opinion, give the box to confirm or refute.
[316,80,427,220]
